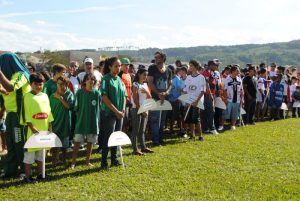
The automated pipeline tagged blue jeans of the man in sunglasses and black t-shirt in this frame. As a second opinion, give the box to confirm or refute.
[149,111,167,144]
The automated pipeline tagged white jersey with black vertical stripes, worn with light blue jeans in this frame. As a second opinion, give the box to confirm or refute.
[224,76,243,103]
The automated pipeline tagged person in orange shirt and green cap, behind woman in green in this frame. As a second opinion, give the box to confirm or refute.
[119,58,132,132]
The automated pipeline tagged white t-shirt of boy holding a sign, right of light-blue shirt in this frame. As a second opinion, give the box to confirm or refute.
[183,74,206,103]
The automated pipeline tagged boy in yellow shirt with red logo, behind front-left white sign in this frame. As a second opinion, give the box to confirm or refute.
[20,73,53,182]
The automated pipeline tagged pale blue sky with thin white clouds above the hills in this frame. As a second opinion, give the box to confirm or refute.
[0,0,300,51]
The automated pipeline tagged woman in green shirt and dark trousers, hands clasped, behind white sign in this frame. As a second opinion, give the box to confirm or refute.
[100,57,127,170]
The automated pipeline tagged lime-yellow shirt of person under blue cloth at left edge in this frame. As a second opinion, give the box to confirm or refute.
[3,72,31,112]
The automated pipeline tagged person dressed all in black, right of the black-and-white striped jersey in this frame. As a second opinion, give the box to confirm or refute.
[243,66,257,124]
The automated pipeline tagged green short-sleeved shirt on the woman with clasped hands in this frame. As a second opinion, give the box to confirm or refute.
[100,73,127,112]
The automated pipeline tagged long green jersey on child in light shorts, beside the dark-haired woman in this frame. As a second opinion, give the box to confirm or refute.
[74,89,101,135]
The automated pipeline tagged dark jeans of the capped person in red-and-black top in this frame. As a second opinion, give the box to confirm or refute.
[203,96,216,130]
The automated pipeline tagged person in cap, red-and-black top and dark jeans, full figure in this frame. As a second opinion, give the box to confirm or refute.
[203,59,220,134]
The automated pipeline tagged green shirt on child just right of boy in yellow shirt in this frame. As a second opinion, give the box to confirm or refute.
[50,90,75,139]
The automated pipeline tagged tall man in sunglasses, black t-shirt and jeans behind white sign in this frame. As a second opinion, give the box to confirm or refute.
[147,52,172,146]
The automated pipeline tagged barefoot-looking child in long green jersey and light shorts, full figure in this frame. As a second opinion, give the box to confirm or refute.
[71,73,101,169]
